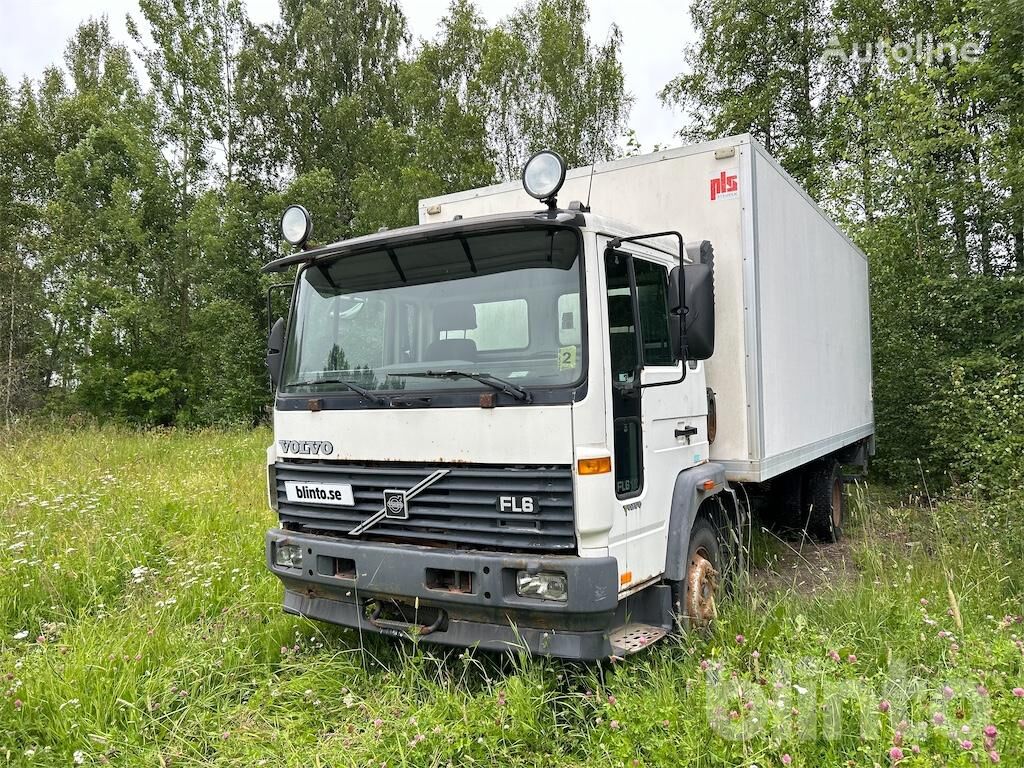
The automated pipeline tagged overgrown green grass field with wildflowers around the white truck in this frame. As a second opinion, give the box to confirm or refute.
[0,429,1024,768]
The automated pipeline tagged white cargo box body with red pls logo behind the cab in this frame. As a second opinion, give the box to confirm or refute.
[420,135,874,481]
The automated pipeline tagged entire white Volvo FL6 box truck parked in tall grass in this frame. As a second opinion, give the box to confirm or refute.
[265,135,873,659]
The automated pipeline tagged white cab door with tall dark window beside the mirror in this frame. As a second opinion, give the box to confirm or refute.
[604,248,707,590]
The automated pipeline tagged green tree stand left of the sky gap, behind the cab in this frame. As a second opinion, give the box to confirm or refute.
[0,0,629,425]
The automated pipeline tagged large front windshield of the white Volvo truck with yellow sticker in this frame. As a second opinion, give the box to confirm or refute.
[282,228,583,401]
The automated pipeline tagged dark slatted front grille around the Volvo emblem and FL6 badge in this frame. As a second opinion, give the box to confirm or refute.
[274,461,575,554]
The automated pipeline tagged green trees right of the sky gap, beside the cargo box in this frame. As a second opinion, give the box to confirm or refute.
[662,0,1024,485]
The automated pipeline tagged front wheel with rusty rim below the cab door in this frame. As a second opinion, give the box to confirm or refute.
[672,517,724,631]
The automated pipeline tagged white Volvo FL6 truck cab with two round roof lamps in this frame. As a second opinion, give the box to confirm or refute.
[265,140,872,659]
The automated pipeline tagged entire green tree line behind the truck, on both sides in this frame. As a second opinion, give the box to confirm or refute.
[0,0,1024,487]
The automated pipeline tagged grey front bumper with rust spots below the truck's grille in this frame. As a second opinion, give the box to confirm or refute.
[266,529,622,659]
